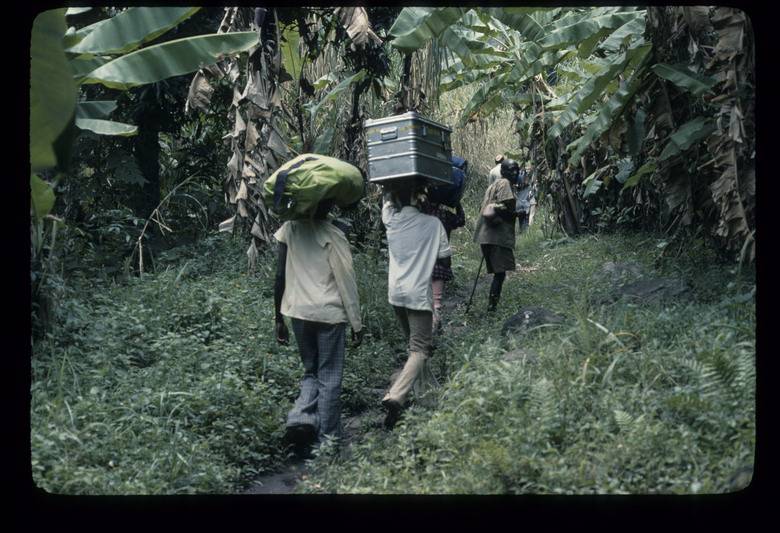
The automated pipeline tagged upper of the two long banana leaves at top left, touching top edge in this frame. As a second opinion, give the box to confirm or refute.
[66,7,200,55]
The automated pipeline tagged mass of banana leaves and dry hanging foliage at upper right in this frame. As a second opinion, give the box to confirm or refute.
[380,7,754,261]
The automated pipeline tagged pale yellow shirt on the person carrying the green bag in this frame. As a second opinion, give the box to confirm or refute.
[274,220,362,331]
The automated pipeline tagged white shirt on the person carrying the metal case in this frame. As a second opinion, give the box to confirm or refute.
[382,197,452,311]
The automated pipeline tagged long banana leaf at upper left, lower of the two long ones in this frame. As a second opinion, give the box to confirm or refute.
[82,31,258,90]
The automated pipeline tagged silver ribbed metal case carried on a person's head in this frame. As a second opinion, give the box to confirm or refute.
[363,111,452,185]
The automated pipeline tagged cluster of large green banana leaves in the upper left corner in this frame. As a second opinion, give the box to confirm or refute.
[30,7,258,220]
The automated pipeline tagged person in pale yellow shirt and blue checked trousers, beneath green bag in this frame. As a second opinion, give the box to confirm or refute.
[274,197,362,455]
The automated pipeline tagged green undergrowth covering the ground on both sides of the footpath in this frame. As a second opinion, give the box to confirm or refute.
[30,213,755,494]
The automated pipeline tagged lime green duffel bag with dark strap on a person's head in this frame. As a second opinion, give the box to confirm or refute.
[263,154,364,220]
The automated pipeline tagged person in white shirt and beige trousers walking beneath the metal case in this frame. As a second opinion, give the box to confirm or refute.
[382,186,452,429]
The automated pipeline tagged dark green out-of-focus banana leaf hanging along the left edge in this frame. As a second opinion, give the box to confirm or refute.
[30,8,76,172]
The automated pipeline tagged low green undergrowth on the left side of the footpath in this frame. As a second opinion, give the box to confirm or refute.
[31,231,393,494]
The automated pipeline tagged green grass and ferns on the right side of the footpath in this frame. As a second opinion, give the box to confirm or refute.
[301,222,755,494]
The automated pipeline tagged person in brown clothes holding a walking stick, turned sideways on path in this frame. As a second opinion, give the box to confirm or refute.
[474,159,520,312]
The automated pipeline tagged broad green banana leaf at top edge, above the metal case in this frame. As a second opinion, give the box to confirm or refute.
[390,7,468,53]
